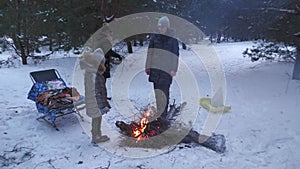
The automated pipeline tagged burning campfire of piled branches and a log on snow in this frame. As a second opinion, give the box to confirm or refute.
[116,101,226,153]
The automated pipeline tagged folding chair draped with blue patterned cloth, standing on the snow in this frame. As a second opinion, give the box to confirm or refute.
[27,69,85,130]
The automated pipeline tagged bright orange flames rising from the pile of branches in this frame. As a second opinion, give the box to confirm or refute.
[132,107,153,142]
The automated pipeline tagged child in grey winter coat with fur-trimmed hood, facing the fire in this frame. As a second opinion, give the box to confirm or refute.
[80,48,111,143]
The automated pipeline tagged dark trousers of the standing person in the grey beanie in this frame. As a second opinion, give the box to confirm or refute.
[153,83,171,117]
